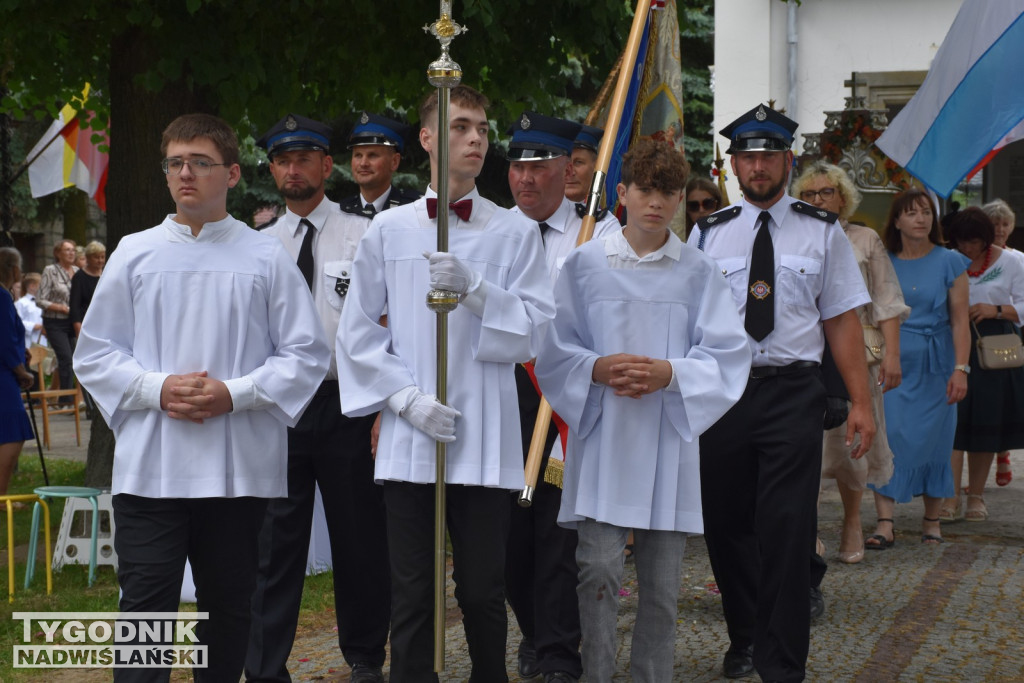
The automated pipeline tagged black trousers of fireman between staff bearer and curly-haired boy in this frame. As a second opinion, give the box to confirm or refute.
[505,366,583,678]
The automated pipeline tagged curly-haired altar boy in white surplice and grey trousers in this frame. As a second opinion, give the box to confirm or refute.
[537,140,751,682]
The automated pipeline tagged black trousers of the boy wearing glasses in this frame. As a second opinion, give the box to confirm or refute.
[113,494,266,683]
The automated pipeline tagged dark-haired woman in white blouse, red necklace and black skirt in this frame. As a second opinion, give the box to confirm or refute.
[942,207,1024,521]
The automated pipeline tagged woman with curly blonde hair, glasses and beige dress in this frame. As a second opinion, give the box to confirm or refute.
[793,161,910,564]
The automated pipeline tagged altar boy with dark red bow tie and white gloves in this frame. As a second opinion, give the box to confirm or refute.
[337,85,554,683]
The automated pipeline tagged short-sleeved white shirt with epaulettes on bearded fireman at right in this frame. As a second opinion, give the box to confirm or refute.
[689,195,871,366]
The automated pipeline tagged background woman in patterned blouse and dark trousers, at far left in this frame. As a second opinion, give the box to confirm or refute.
[36,240,78,401]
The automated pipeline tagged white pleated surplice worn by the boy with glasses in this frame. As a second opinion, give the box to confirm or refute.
[75,216,331,498]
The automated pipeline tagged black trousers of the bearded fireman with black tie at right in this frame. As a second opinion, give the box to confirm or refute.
[700,369,824,681]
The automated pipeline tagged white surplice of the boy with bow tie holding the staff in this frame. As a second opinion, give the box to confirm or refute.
[337,188,554,489]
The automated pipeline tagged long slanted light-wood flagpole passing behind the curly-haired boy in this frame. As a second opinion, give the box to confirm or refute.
[519,0,650,508]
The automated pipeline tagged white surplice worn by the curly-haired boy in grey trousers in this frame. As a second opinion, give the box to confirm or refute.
[537,232,751,533]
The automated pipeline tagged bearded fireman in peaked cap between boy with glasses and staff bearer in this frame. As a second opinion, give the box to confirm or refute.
[246,114,390,683]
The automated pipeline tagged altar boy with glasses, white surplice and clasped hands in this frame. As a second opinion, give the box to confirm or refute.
[75,114,331,681]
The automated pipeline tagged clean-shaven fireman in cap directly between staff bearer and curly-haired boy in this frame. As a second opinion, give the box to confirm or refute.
[505,112,621,683]
